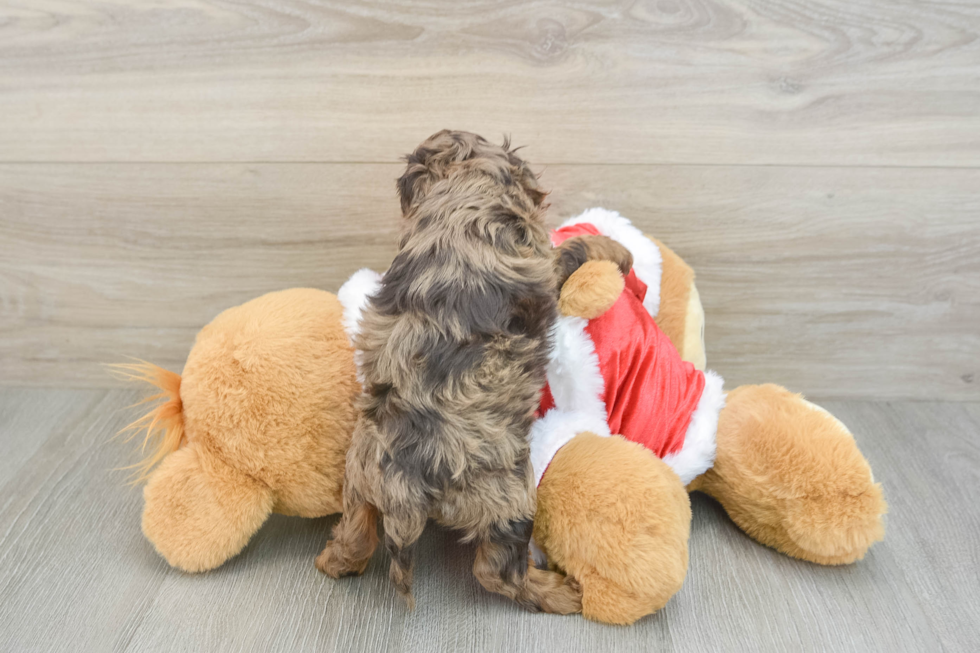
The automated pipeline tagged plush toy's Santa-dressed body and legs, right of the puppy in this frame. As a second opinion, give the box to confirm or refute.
[531,209,886,624]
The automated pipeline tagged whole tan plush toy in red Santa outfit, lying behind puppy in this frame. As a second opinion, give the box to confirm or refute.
[117,209,885,624]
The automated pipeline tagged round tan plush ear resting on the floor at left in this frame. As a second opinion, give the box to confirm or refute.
[143,443,275,572]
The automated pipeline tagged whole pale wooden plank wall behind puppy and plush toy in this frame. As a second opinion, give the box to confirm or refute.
[0,0,980,400]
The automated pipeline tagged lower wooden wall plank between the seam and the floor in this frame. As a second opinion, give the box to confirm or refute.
[0,164,980,400]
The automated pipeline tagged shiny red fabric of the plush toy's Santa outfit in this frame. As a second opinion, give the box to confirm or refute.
[540,224,704,458]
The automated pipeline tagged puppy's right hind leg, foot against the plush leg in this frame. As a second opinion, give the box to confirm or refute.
[473,517,582,614]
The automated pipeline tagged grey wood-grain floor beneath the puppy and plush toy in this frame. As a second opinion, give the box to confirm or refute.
[0,389,980,653]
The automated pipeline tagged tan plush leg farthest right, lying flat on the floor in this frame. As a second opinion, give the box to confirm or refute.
[688,384,886,565]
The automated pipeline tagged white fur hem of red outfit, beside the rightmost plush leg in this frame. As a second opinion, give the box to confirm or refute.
[664,370,725,485]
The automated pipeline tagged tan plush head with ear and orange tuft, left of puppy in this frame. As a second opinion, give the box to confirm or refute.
[120,288,360,571]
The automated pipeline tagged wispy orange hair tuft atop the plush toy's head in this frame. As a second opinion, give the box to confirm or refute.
[108,361,184,483]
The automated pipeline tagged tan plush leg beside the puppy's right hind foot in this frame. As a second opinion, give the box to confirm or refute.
[534,433,691,624]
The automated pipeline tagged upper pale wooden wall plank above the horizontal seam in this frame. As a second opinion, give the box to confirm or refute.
[0,0,980,166]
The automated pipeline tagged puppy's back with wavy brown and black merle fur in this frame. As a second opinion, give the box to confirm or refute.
[357,174,557,486]
